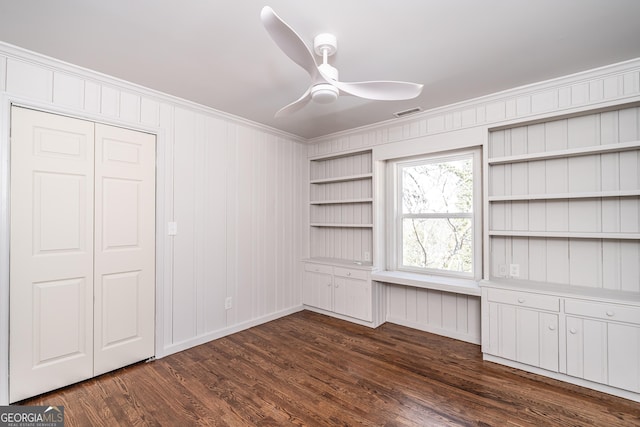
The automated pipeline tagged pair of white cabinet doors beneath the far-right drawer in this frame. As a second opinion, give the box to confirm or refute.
[567,316,640,392]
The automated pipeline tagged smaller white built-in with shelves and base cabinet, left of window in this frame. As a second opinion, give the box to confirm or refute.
[302,150,385,327]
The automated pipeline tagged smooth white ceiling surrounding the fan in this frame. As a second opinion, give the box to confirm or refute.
[0,0,640,138]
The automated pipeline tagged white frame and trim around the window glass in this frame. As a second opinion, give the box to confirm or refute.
[385,147,483,281]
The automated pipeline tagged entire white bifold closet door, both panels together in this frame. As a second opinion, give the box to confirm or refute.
[9,107,155,402]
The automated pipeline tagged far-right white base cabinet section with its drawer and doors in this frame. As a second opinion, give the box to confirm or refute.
[565,299,640,393]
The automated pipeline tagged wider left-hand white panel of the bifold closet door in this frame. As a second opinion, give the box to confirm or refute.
[9,107,94,402]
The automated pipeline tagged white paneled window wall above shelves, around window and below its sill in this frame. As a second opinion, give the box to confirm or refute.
[307,59,640,343]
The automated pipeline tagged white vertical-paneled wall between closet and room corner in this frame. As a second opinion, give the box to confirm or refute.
[165,112,306,347]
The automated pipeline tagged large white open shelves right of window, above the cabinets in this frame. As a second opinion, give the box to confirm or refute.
[488,108,640,293]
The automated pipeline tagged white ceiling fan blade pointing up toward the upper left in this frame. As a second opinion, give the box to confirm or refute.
[260,6,320,81]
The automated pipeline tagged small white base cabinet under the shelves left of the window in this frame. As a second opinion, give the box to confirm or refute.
[303,263,377,326]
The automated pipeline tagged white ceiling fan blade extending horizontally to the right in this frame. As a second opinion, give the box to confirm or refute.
[328,80,424,101]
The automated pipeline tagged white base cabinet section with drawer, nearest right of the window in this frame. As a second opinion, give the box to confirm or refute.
[484,289,560,371]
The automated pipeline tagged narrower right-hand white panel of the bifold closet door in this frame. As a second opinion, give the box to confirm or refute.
[94,124,155,375]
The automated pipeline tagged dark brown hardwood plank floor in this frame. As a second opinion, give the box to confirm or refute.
[21,311,640,427]
